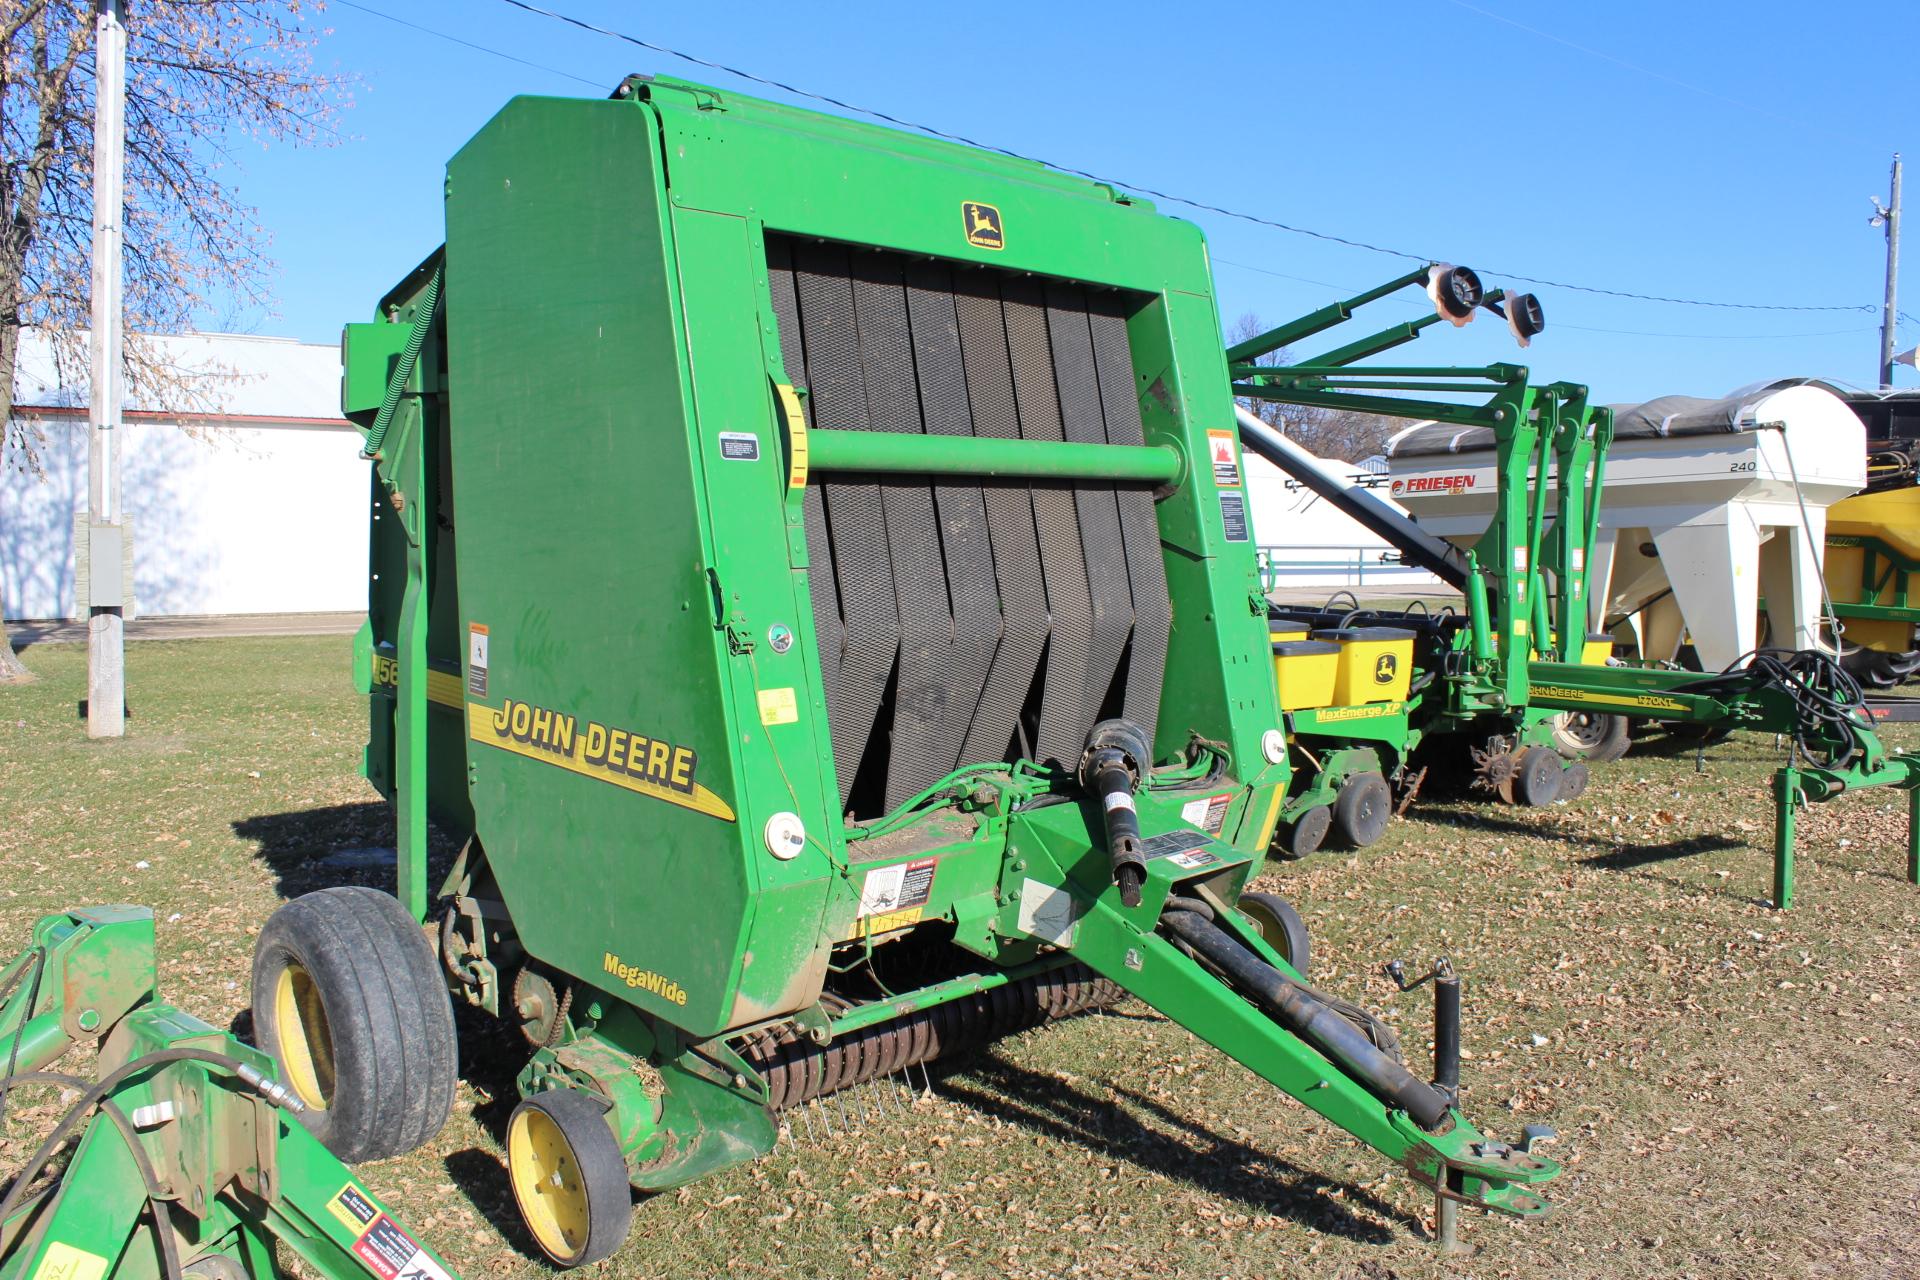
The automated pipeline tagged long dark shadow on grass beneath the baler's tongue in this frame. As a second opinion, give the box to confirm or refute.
[933,1054,1421,1245]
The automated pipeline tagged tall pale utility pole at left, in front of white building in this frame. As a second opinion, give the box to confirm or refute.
[86,0,127,737]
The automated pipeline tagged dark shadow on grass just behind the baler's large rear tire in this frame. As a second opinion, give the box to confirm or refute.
[232,800,457,898]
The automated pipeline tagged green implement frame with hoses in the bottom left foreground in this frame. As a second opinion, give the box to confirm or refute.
[0,906,449,1280]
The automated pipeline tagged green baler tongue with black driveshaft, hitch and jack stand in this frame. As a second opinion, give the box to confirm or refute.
[1008,806,1559,1236]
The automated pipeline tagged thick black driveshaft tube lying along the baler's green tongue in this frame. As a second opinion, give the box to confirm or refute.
[1160,912,1450,1128]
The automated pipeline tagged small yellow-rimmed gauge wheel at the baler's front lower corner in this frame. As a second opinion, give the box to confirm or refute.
[507,1088,634,1267]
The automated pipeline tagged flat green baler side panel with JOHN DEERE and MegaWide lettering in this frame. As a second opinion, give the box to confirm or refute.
[447,98,758,1032]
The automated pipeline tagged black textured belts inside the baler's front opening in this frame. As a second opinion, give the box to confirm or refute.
[768,236,1171,816]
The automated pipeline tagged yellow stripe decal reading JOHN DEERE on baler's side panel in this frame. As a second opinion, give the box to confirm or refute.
[467,699,733,821]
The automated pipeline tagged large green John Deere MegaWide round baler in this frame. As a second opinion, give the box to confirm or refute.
[255,79,1557,1265]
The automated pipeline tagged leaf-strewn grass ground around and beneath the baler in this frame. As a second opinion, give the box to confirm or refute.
[0,637,1920,1280]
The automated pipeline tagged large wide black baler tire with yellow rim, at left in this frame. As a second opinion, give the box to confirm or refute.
[253,887,459,1163]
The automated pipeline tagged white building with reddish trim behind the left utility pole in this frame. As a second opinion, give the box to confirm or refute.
[0,332,371,620]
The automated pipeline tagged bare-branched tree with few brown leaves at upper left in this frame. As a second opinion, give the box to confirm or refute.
[0,0,346,681]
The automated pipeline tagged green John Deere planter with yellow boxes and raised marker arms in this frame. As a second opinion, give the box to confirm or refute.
[1227,263,1920,908]
